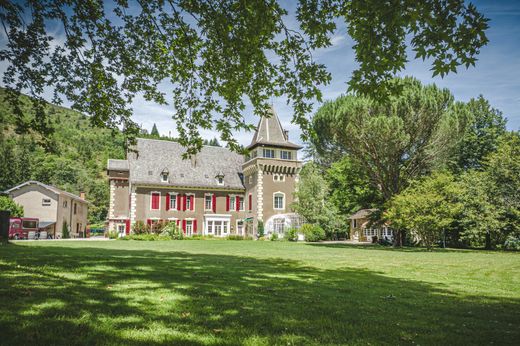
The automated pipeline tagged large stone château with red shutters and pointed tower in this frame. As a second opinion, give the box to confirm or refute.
[107,111,302,237]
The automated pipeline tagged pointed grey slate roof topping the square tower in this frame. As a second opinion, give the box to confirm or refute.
[247,106,302,149]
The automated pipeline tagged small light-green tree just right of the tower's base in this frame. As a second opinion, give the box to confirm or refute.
[291,163,341,237]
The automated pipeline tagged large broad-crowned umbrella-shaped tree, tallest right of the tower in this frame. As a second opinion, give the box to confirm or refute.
[312,78,467,201]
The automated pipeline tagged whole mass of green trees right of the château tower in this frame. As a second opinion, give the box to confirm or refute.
[302,78,520,248]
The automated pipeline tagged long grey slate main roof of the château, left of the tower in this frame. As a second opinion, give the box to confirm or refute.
[128,138,245,190]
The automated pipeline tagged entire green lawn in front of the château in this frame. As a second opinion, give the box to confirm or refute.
[0,241,520,345]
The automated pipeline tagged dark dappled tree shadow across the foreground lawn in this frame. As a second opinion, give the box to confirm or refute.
[0,245,520,345]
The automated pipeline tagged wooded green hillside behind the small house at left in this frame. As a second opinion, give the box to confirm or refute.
[0,89,125,222]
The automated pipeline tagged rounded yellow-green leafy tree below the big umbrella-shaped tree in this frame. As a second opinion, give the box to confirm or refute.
[385,173,462,249]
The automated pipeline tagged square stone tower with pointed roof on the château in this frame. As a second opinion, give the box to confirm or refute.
[242,108,302,236]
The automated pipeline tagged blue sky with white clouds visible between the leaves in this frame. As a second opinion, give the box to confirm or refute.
[0,0,520,145]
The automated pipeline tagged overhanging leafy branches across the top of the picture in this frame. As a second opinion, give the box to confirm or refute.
[0,0,488,154]
